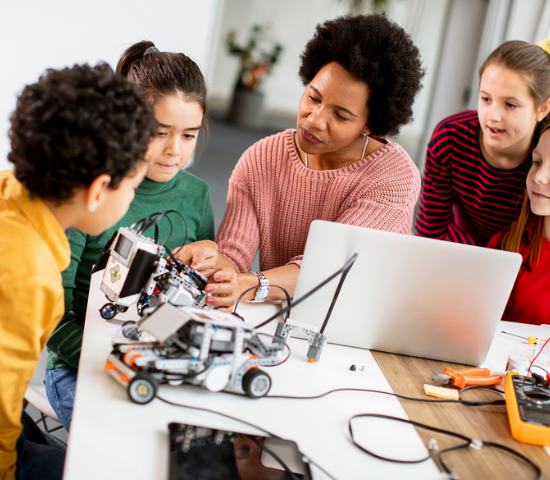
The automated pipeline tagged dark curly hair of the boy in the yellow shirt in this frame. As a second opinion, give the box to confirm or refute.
[8,64,157,203]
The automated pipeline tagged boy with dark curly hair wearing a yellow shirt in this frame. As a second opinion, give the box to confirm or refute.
[0,64,157,480]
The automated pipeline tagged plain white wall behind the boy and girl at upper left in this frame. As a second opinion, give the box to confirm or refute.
[0,0,223,170]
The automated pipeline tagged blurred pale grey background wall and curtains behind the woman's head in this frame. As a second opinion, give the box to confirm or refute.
[211,0,550,168]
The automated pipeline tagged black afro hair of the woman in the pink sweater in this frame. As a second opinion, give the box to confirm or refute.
[299,14,424,137]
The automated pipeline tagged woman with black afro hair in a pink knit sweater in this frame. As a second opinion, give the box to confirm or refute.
[181,15,424,301]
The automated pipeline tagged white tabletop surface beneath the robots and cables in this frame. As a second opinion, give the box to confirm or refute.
[64,272,537,480]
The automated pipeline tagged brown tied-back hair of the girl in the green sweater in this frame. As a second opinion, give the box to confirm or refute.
[115,40,208,156]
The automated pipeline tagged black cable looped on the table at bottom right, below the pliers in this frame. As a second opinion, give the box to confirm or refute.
[348,413,542,480]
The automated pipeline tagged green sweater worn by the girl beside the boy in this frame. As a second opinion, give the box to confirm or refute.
[46,170,215,370]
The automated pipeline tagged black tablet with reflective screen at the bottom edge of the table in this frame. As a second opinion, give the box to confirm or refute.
[168,423,315,480]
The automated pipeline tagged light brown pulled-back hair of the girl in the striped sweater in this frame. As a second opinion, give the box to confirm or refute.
[479,40,550,138]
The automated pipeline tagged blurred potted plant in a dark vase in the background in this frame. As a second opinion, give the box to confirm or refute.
[225,25,283,127]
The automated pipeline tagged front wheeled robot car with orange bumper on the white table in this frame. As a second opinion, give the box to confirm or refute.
[105,303,285,404]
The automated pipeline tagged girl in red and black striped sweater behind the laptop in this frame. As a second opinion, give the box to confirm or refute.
[415,40,550,246]
